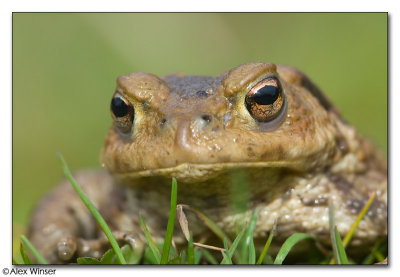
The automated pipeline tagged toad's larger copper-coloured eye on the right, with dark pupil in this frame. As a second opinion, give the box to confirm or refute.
[245,77,284,122]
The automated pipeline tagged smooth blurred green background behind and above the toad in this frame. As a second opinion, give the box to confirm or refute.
[13,13,388,239]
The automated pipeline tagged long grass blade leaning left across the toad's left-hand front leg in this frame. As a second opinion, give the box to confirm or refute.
[58,153,126,264]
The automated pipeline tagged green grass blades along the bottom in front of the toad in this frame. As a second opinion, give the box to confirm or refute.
[13,155,387,265]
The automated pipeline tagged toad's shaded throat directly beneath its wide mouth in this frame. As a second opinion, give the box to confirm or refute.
[114,163,296,203]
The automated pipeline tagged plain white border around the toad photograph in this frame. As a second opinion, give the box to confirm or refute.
[0,0,400,277]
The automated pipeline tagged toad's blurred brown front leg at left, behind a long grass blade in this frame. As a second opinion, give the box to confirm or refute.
[28,171,140,263]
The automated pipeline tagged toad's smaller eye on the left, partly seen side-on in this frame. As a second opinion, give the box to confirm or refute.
[111,93,135,133]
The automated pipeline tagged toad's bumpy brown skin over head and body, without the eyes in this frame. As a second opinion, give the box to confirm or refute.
[30,63,387,263]
